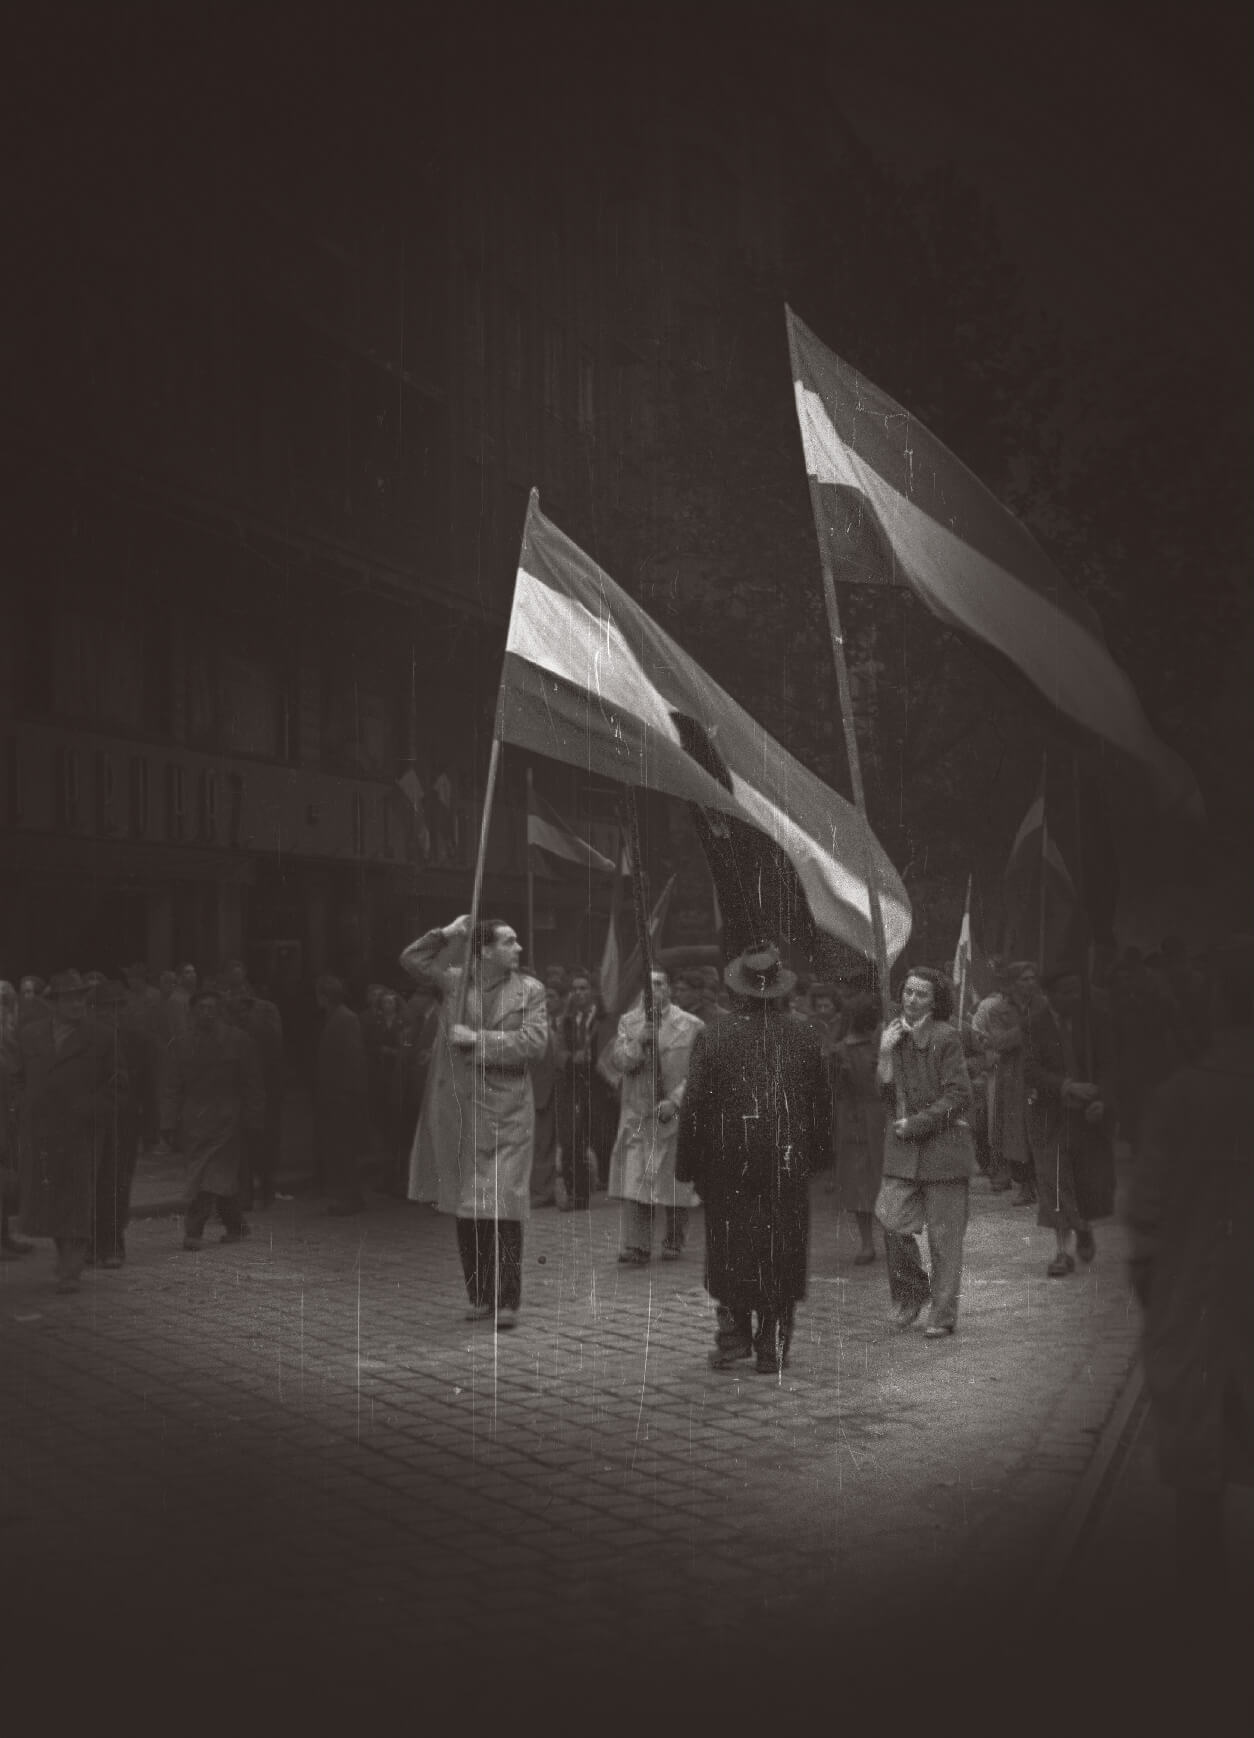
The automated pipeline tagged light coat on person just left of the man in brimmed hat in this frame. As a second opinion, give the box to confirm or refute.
[610,1003,702,1206]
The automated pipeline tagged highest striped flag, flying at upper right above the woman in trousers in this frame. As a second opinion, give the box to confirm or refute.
[787,309,1202,817]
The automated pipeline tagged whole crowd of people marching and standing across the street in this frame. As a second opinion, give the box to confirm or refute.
[0,918,1254,1592]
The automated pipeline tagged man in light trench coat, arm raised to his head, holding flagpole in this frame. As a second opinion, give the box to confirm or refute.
[401,918,549,1330]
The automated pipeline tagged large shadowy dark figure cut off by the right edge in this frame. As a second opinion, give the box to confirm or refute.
[1129,937,1254,1613]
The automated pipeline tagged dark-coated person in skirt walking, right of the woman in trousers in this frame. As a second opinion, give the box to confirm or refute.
[1023,966,1115,1279]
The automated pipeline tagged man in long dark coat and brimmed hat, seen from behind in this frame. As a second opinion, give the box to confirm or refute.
[676,945,832,1376]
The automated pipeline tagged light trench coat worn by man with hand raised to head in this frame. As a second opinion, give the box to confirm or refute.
[401,930,549,1220]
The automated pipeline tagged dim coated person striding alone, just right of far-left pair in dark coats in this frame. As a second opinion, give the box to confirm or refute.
[162,985,266,1250]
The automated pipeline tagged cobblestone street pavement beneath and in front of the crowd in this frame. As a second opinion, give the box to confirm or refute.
[0,1160,1208,1717]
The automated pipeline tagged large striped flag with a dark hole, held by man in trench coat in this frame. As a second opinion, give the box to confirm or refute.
[497,492,910,959]
